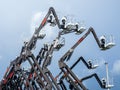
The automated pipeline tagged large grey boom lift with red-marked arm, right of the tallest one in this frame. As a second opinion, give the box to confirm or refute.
[59,27,114,90]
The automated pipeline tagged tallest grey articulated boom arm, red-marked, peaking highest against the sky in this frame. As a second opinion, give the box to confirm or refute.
[2,7,61,90]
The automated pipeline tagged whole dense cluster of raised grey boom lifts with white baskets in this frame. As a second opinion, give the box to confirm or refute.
[0,7,115,90]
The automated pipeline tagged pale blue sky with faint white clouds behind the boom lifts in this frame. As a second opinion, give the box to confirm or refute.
[0,0,120,90]
